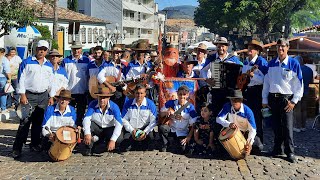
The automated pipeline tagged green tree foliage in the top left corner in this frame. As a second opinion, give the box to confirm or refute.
[0,0,37,37]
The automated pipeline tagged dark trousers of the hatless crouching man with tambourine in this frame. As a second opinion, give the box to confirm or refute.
[120,128,154,151]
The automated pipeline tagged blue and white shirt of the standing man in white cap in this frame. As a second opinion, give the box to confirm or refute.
[17,56,56,97]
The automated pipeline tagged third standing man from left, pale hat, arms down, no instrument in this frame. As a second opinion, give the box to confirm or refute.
[61,42,90,125]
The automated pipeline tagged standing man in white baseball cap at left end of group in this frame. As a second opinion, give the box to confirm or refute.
[12,40,56,158]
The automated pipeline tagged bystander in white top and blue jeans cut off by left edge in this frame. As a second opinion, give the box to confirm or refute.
[0,48,11,113]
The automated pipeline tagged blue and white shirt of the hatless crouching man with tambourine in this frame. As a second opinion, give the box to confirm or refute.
[122,98,157,134]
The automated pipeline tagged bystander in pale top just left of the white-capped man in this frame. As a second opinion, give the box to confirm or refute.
[7,47,22,107]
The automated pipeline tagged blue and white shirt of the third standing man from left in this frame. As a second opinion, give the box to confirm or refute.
[61,56,90,94]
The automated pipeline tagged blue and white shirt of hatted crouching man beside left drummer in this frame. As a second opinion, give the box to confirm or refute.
[82,100,122,141]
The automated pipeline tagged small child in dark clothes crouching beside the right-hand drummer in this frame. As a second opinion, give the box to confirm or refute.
[193,103,215,155]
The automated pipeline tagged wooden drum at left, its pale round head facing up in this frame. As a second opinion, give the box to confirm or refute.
[48,126,77,161]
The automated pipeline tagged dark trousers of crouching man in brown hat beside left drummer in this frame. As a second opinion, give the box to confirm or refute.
[86,121,123,149]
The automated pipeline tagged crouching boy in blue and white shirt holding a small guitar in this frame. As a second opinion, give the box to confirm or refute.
[159,85,197,153]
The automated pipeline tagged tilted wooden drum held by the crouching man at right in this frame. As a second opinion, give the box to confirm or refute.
[219,127,247,159]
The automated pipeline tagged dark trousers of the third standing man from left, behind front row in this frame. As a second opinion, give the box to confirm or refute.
[70,94,88,127]
